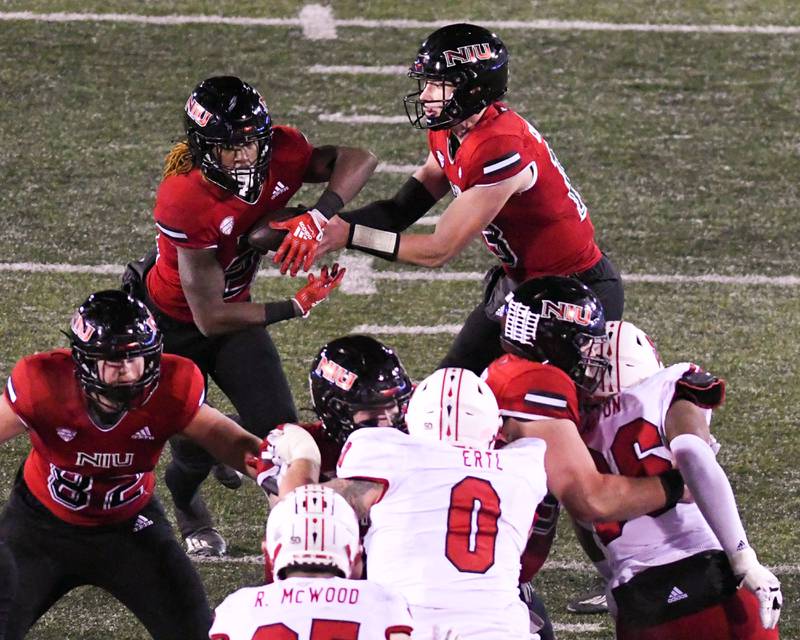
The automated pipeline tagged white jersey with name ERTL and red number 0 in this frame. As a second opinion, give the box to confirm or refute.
[337,429,547,638]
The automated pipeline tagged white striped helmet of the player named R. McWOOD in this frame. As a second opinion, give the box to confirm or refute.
[265,484,360,580]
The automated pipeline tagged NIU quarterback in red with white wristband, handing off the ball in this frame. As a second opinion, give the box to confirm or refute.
[320,24,623,373]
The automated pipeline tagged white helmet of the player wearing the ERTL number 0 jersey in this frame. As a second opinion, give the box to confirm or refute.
[406,368,502,448]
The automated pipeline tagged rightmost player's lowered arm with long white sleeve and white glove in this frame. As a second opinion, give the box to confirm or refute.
[664,400,783,629]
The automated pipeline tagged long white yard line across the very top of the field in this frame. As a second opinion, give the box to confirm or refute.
[0,11,800,35]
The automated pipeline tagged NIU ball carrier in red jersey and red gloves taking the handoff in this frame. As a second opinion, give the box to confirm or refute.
[138,76,376,555]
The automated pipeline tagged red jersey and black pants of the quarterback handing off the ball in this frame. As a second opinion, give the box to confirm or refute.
[428,103,623,374]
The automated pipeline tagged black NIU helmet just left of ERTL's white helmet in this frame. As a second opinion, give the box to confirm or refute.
[308,335,413,443]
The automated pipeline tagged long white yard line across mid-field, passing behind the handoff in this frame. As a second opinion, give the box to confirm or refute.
[0,262,800,287]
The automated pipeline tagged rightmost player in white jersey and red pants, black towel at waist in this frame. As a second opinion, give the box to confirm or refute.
[582,322,782,640]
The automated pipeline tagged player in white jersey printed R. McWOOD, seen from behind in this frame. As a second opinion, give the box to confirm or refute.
[209,485,412,640]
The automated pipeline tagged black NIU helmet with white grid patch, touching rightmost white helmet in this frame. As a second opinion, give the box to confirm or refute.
[500,276,609,394]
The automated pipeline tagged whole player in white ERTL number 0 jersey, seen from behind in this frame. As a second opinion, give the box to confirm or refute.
[266,368,546,640]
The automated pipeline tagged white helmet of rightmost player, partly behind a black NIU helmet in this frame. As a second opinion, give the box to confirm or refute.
[594,320,664,397]
